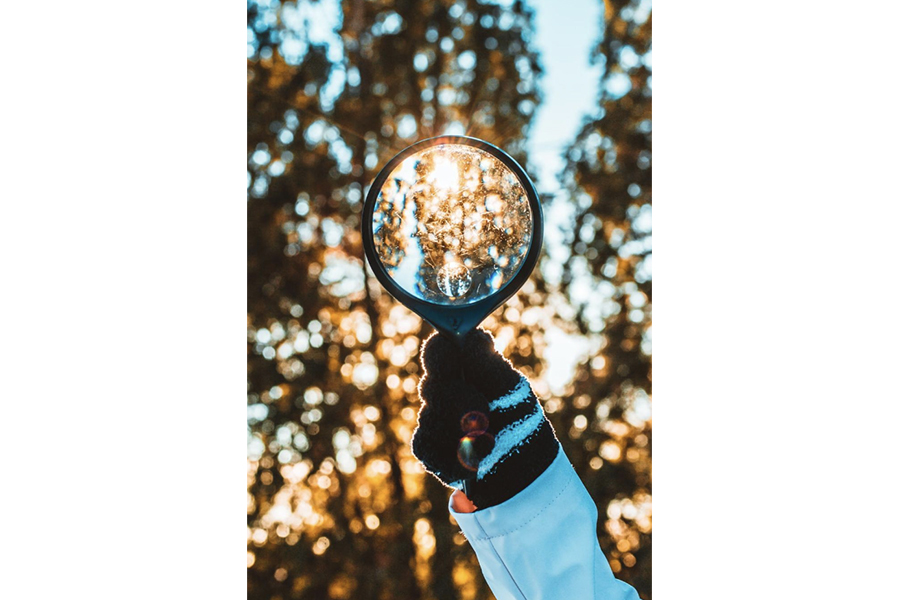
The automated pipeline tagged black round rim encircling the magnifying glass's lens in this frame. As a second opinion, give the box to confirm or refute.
[361,135,544,343]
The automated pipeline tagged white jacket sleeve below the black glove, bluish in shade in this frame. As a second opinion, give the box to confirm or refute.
[450,448,639,600]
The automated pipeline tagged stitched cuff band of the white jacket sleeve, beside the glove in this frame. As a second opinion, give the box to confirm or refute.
[448,442,580,542]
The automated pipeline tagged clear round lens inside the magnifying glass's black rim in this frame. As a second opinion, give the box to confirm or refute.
[372,143,534,305]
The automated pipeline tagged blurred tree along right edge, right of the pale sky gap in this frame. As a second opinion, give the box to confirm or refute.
[554,0,652,598]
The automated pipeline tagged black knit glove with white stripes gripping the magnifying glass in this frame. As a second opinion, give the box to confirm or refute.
[412,329,559,509]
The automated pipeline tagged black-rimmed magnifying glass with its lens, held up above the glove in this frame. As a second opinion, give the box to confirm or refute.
[362,136,543,343]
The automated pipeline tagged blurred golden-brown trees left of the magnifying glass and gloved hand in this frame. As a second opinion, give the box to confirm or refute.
[247,0,541,599]
